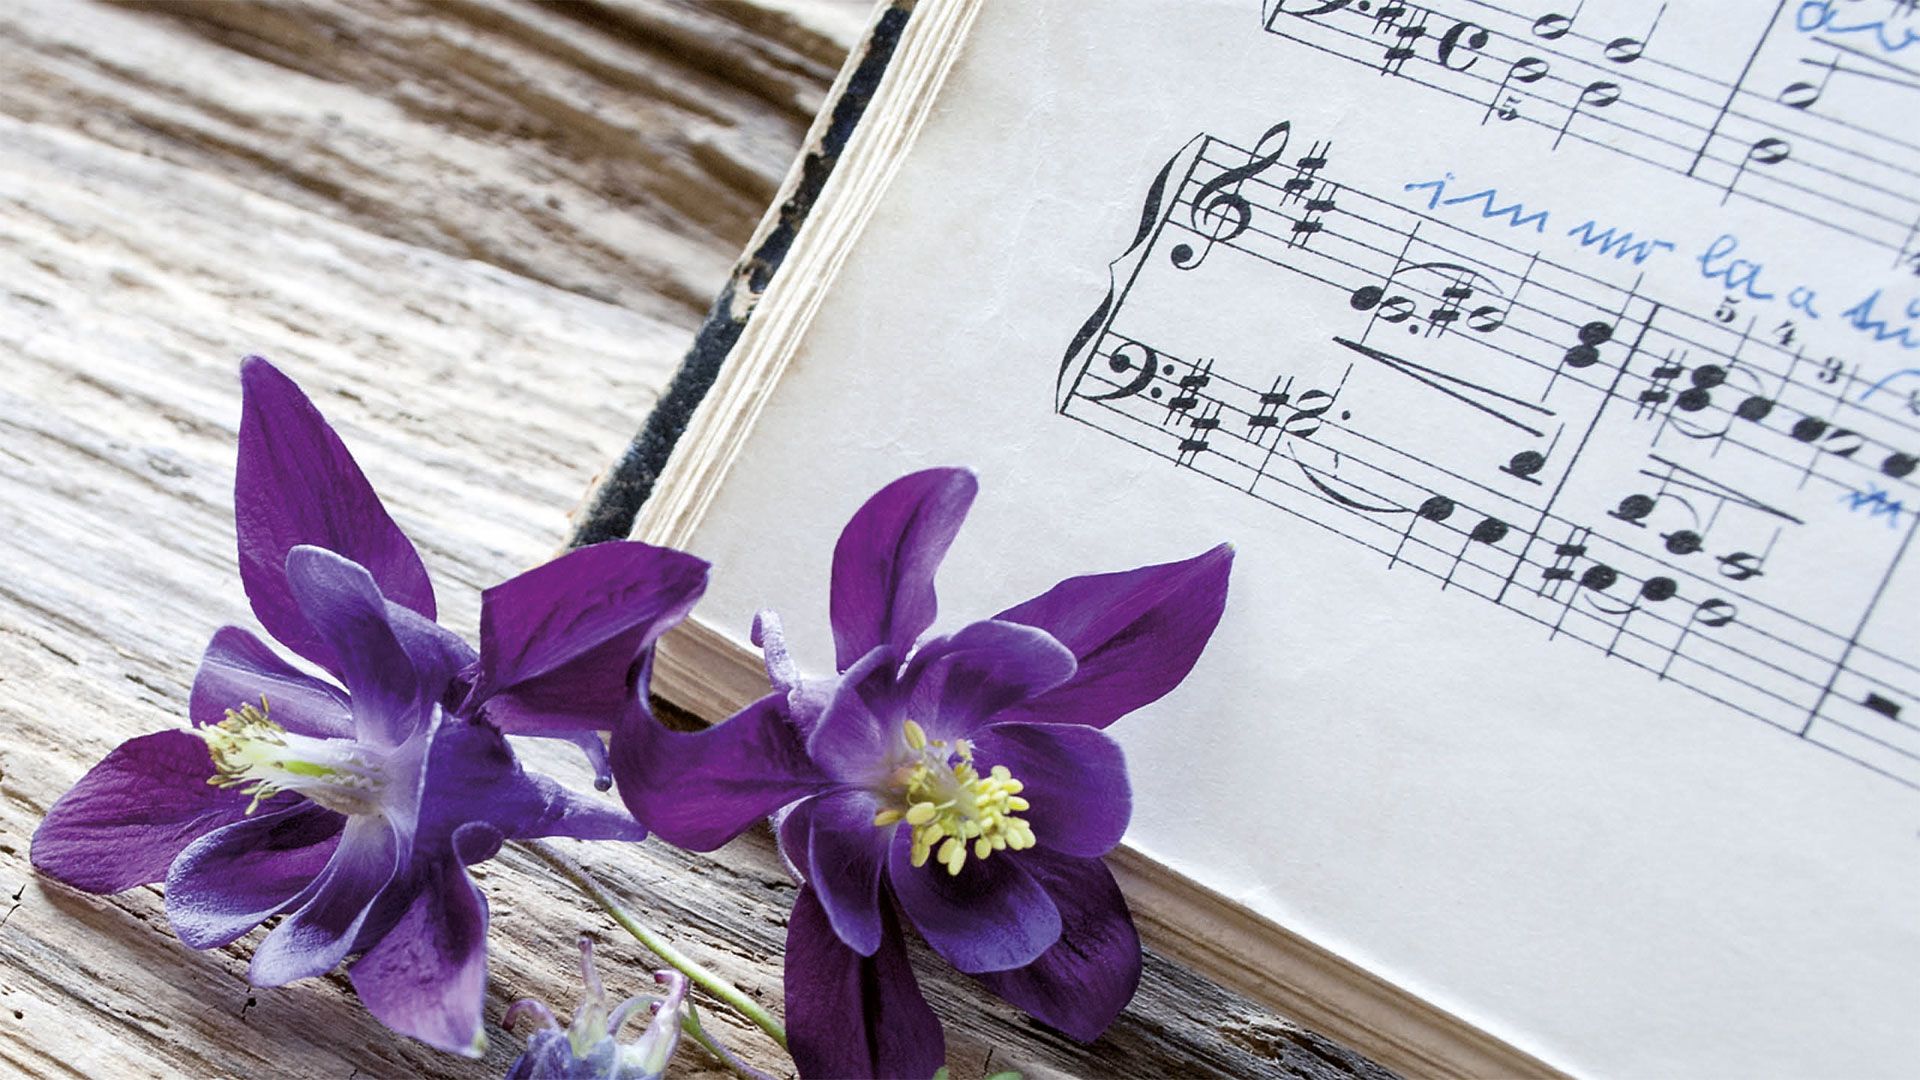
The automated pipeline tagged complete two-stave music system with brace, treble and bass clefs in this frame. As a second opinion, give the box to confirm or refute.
[1056,119,1920,788]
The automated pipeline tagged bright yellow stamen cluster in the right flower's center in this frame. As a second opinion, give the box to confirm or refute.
[874,721,1033,874]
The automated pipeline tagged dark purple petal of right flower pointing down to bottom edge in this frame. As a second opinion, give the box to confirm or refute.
[785,888,947,1078]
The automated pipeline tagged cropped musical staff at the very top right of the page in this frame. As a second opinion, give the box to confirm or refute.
[1263,0,1920,275]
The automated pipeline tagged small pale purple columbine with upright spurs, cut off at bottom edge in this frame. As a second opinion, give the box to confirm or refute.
[507,936,691,1080]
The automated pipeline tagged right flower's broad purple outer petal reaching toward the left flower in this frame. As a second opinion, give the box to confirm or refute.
[612,694,829,851]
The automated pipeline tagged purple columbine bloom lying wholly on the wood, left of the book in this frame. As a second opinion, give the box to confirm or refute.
[33,357,707,1053]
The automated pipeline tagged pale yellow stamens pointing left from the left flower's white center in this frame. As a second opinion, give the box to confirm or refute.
[200,696,378,815]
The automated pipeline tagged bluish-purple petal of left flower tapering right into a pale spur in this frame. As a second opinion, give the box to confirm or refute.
[415,721,647,845]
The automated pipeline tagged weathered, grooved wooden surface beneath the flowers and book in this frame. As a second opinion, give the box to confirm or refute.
[0,0,1375,1076]
